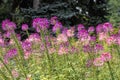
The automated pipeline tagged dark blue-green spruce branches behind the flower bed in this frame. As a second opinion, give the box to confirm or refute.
[12,0,108,27]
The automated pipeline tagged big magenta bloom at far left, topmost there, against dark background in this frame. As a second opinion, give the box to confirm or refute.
[2,19,16,32]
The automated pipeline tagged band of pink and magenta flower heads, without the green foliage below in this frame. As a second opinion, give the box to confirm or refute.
[0,16,120,77]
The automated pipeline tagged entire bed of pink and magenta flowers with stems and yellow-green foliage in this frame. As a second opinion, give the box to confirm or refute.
[0,16,120,80]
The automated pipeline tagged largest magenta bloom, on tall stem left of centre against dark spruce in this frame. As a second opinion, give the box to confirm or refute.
[32,18,49,32]
